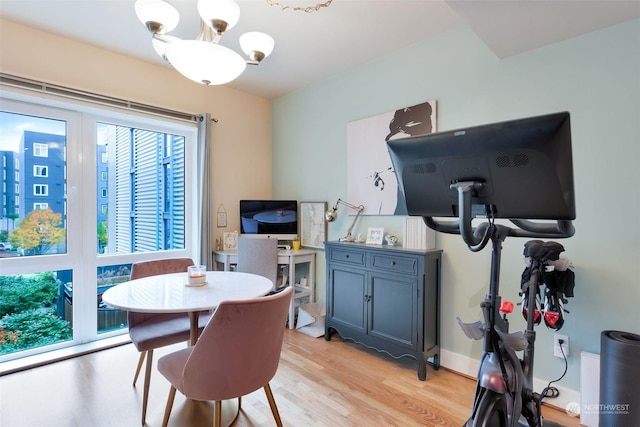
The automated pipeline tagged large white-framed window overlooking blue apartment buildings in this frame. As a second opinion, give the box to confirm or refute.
[0,98,198,363]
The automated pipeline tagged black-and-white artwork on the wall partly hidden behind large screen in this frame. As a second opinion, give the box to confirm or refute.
[347,100,437,215]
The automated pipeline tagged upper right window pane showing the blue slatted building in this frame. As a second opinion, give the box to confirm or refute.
[97,123,186,254]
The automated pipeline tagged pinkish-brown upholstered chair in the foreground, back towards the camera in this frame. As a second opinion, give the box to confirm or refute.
[158,286,293,426]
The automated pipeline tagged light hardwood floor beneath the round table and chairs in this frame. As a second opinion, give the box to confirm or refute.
[0,330,580,427]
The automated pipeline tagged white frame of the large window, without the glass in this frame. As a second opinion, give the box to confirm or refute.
[0,91,200,362]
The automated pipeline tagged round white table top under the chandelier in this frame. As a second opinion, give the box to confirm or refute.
[102,271,273,313]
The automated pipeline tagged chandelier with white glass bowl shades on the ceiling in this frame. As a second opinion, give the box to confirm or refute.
[135,0,274,85]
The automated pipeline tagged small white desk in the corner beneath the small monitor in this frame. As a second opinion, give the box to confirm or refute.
[213,249,316,329]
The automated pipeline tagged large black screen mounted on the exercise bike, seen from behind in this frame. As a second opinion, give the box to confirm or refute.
[387,112,576,220]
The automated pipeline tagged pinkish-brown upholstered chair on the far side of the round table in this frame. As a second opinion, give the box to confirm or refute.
[127,258,210,425]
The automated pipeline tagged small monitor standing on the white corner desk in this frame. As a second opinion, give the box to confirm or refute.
[240,200,298,240]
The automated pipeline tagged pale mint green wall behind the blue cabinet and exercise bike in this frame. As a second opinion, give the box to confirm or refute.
[273,20,640,390]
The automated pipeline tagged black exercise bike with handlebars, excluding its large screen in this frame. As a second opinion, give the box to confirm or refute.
[424,181,575,427]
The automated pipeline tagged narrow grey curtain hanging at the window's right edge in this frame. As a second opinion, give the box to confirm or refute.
[198,113,213,270]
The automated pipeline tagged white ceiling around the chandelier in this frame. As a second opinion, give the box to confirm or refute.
[0,0,640,99]
